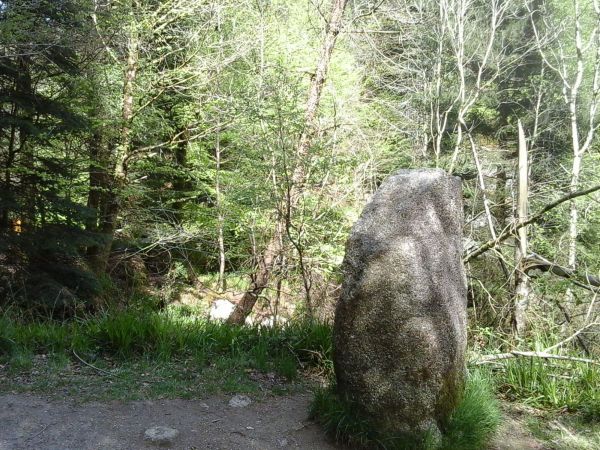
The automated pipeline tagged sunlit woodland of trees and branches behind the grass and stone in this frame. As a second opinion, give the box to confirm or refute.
[0,0,600,418]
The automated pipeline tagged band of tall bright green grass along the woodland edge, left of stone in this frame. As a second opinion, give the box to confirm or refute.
[0,310,331,380]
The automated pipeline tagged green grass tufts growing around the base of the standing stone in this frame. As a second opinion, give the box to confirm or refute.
[311,371,501,450]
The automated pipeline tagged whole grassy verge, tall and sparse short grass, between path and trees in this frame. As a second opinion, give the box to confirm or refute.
[0,309,332,398]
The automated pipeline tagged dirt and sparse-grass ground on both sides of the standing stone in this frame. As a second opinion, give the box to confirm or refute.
[0,359,598,450]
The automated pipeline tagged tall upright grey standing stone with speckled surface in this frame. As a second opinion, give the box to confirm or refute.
[334,169,467,435]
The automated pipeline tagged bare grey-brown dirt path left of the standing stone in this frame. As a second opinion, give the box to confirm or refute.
[0,394,337,450]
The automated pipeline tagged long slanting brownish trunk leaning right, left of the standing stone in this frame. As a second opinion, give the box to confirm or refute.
[228,0,347,324]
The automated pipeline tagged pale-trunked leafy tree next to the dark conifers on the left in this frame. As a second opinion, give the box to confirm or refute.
[83,0,212,272]
